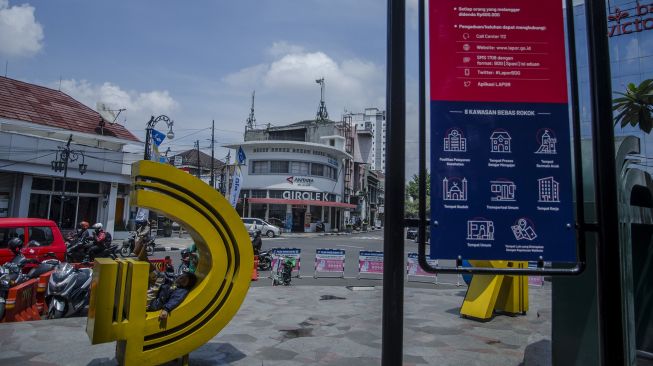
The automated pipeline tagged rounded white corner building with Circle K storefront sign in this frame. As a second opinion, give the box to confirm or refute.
[226,121,356,232]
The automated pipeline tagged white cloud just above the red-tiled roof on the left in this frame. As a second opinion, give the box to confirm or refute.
[56,79,179,131]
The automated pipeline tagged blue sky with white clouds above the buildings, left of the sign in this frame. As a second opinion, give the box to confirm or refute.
[0,0,417,175]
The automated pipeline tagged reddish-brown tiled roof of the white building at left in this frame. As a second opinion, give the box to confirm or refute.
[0,77,139,141]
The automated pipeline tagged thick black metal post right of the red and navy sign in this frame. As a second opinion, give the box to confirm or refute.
[585,0,626,365]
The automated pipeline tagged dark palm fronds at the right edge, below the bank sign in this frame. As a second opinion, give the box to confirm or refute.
[612,79,653,133]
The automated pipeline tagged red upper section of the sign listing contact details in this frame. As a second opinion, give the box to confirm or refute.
[429,0,567,103]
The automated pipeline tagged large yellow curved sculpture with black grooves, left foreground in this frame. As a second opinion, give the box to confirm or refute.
[86,161,253,365]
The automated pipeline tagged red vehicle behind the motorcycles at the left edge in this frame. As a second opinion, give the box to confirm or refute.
[0,218,66,265]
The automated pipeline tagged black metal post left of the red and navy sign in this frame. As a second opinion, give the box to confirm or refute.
[381,0,406,366]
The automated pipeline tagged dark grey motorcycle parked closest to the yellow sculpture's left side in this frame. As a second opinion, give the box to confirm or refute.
[45,262,91,319]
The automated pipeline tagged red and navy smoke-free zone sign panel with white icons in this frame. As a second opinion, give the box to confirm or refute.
[428,0,577,262]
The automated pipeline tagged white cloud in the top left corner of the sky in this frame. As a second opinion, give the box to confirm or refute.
[0,0,43,57]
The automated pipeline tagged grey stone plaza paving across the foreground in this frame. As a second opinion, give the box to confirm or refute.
[0,283,551,366]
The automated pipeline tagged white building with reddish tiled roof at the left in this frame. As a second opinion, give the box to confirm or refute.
[0,77,140,233]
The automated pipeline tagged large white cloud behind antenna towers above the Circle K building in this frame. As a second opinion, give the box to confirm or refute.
[223,42,385,124]
